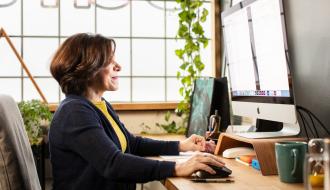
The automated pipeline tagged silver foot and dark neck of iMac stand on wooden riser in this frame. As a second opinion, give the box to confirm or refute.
[228,119,300,139]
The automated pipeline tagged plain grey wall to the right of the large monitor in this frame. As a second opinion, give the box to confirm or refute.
[283,0,330,137]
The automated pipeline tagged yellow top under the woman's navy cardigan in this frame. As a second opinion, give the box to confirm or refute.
[93,100,127,152]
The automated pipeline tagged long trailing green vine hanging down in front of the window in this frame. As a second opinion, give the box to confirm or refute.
[175,0,208,129]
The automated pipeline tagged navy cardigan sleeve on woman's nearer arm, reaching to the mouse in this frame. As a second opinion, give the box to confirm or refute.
[58,105,175,183]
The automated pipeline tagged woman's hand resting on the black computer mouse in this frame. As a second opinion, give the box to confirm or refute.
[174,153,225,177]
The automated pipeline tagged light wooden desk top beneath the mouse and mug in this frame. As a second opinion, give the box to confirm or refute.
[143,135,303,190]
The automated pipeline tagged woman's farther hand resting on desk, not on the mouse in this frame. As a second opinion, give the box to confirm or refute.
[179,134,216,153]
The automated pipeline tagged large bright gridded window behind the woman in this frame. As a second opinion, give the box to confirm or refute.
[0,0,212,103]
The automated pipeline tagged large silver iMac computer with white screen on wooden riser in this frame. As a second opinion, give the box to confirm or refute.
[221,0,300,138]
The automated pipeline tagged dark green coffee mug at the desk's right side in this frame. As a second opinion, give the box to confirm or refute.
[275,141,308,183]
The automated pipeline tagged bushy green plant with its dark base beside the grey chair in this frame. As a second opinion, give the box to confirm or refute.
[18,100,52,189]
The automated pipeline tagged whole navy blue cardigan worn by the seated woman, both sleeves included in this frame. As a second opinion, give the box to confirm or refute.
[49,95,179,190]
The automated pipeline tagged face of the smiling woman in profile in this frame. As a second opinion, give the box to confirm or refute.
[100,58,121,91]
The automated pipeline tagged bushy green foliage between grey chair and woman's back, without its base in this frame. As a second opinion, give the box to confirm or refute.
[18,100,52,145]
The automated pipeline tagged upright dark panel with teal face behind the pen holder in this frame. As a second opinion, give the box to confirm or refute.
[186,77,230,137]
